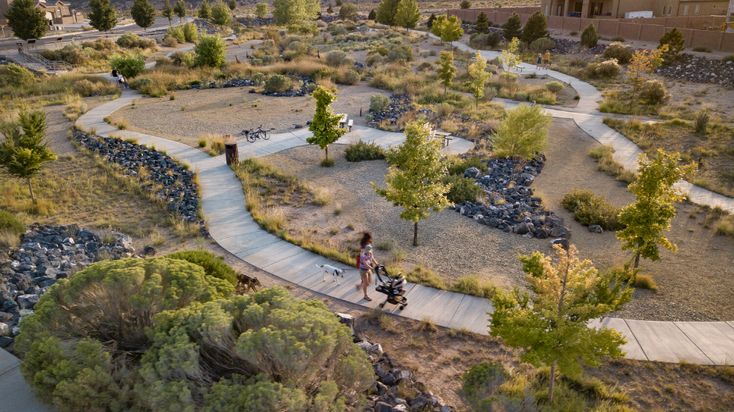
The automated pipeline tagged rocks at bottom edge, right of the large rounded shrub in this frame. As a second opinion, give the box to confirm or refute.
[337,313,454,412]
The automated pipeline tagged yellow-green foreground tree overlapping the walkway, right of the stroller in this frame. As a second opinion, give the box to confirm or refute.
[490,245,631,404]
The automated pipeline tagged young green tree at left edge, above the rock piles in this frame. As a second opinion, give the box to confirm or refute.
[0,111,56,204]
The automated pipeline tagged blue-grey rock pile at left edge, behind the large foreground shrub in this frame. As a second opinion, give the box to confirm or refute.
[0,225,135,348]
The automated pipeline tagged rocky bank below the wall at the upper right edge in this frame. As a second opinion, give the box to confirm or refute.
[657,54,734,87]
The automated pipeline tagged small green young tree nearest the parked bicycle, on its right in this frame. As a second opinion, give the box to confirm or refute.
[306,86,347,166]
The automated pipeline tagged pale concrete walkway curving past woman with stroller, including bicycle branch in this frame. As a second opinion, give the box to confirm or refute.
[77,91,734,365]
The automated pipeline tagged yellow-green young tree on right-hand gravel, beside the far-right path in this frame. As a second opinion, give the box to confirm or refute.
[617,149,693,269]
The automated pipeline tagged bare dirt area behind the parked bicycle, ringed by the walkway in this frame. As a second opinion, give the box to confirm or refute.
[111,85,388,146]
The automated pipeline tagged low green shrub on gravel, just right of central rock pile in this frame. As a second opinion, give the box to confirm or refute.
[561,190,622,230]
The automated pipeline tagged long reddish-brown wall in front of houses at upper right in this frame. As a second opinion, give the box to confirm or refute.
[447,7,734,52]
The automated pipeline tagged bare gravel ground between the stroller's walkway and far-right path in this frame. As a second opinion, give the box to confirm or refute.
[263,119,734,320]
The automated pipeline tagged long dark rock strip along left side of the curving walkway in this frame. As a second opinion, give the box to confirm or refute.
[73,130,203,227]
